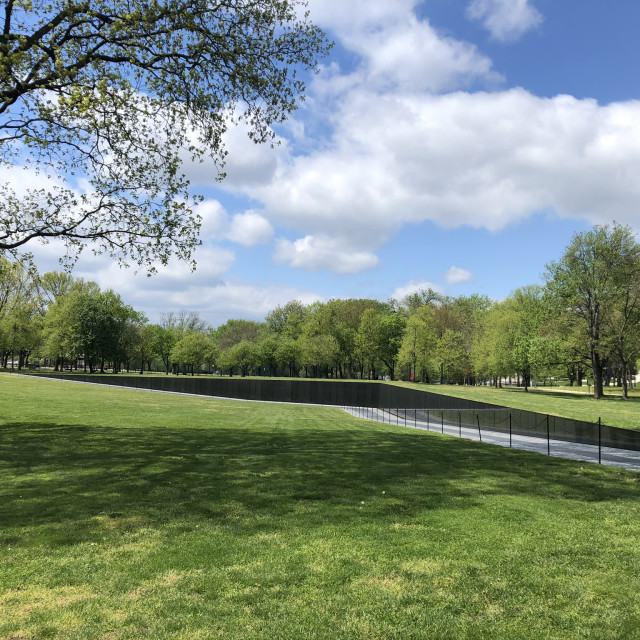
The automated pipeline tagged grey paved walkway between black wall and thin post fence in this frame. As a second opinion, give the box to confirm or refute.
[346,407,640,471]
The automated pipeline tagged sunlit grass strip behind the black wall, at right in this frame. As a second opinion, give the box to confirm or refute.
[391,382,640,430]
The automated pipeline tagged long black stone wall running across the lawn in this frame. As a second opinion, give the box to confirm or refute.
[27,372,640,458]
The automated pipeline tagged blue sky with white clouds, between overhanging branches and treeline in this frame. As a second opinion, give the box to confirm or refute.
[31,0,640,325]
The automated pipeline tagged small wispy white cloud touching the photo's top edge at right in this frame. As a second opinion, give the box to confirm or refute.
[467,0,543,42]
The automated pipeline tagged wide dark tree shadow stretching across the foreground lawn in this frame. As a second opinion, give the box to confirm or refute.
[0,423,640,544]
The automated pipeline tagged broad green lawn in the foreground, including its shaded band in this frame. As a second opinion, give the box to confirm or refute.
[0,375,640,640]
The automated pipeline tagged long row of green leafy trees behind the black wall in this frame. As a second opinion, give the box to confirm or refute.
[0,224,640,397]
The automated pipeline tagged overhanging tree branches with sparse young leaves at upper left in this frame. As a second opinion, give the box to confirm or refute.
[0,0,328,271]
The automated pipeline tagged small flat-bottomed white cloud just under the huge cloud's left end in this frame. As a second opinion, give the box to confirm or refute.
[274,235,378,274]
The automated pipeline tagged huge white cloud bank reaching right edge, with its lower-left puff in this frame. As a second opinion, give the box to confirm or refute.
[251,89,640,262]
